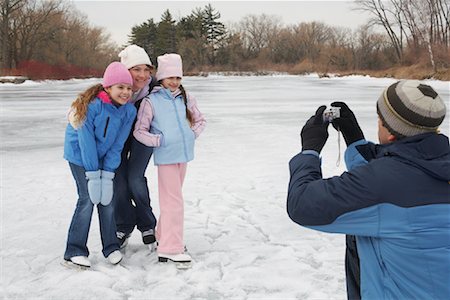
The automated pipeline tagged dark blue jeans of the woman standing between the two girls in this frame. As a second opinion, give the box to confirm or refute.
[113,137,156,234]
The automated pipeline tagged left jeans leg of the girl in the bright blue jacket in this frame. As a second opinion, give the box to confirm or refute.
[64,163,94,260]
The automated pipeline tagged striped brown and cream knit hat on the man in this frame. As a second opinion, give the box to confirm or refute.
[377,80,447,139]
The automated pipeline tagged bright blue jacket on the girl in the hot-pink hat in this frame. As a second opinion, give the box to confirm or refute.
[64,98,136,172]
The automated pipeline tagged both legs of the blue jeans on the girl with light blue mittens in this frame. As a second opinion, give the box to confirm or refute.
[64,162,119,260]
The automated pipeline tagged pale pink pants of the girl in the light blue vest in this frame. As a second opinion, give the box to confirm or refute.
[156,163,187,254]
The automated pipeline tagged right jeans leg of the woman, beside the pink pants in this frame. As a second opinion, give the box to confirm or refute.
[128,138,156,232]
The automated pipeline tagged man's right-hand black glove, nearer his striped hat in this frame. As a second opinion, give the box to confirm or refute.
[331,102,364,146]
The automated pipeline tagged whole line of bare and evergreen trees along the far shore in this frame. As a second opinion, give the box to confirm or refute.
[0,0,450,79]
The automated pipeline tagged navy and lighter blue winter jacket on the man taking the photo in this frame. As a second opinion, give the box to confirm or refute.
[287,133,450,299]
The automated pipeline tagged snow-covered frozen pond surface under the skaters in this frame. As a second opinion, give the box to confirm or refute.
[0,75,450,299]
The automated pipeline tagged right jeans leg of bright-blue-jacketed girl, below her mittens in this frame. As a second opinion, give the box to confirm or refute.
[97,203,120,257]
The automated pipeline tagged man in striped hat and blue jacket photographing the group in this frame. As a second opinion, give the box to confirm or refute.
[287,80,450,299]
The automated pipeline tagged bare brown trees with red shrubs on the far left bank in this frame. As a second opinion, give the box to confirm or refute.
[0,0,117,78]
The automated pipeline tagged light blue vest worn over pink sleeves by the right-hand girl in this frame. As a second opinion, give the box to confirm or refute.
[149,88,195,165]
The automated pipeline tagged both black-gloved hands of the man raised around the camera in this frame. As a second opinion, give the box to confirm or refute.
[300,102,364,153]
